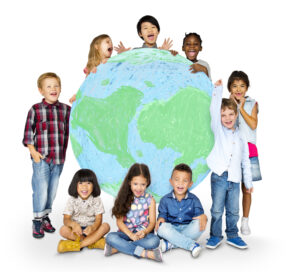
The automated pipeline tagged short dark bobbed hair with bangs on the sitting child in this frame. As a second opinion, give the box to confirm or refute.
[68,169,101,198]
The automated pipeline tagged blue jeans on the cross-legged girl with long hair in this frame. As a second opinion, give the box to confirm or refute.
[105,231,160,258]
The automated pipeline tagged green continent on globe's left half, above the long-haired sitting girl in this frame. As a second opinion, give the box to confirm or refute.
[71,86,143,168]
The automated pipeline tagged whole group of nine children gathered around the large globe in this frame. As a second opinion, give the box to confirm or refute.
[23,16,261,261]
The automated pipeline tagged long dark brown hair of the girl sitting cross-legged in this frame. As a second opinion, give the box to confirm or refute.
[112,163,151,218]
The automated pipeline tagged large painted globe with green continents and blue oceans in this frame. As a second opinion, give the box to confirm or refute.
[70,49,214,201]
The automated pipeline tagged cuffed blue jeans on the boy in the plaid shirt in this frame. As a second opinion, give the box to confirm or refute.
[32,160,64,217]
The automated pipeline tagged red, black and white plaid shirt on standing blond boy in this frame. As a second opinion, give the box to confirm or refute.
[23,99,71,164]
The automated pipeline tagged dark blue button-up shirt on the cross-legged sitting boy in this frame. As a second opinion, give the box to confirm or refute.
[158,191,204,226]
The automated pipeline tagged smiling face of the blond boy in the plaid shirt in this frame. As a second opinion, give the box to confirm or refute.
[39,77,61,104]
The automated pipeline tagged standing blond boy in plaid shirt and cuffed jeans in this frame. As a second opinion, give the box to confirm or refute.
[23,73,71,238]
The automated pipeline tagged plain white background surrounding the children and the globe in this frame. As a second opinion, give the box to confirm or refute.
[0,0,300,271]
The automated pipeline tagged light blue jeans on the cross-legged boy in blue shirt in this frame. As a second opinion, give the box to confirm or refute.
[157,219,203,250]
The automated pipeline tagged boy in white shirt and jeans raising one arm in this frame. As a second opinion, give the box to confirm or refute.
[206,80,253,249]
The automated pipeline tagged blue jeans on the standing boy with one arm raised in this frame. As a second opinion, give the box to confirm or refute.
[210,172,240,239]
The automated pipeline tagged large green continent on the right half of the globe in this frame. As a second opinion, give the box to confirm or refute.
[138,87,214,168]
